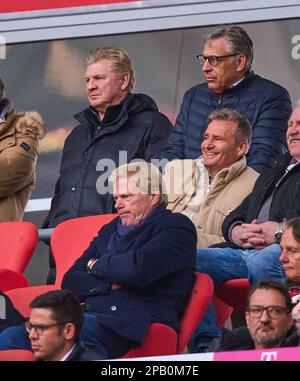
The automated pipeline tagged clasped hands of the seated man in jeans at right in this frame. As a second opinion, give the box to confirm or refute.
[231,220,266,249]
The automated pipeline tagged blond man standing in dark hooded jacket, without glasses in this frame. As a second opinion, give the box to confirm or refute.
[43,48,172,283]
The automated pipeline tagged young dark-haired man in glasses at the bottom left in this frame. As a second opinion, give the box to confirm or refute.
[0,290,107,361]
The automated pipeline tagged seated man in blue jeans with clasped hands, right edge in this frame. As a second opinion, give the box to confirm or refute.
[193,106,300,347]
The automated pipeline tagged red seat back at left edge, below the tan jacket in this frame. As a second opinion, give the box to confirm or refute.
[0,222,38,273]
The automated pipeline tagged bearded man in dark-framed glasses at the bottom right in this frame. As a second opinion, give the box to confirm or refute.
[209,281,297,352]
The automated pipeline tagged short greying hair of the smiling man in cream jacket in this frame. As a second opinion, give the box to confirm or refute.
[208,108,252,146]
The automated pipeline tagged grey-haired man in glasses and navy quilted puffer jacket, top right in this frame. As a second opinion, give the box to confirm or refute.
[161,26,292,172]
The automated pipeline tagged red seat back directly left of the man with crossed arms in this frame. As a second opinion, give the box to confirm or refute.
[51,214,117,287]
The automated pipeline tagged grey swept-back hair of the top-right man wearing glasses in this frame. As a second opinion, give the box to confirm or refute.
[204,25,253,71]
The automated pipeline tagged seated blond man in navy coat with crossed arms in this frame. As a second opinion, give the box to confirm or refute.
[0,162,197,358]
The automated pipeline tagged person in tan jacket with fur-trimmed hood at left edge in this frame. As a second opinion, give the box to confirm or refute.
[0,78,44,222]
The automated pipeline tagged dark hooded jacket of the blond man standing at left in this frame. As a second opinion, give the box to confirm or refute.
[43,94,172,228]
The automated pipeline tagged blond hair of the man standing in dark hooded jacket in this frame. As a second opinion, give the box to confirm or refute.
[86,47,135,91]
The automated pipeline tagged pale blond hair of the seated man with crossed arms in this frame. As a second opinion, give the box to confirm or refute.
[108,161,168,205]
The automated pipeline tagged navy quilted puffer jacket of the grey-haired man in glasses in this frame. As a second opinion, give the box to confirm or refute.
[161,72,292,173]
